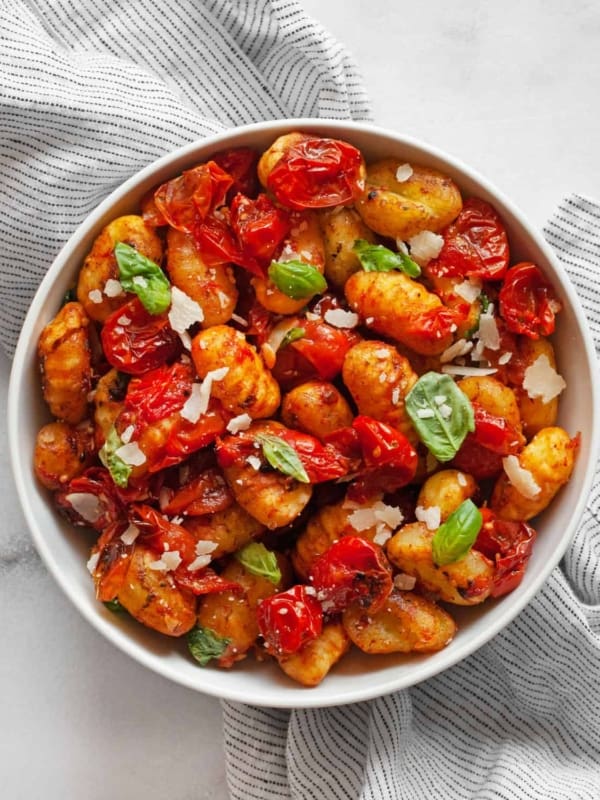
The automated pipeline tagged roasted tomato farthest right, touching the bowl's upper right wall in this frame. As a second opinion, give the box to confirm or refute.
[499,261,561,339]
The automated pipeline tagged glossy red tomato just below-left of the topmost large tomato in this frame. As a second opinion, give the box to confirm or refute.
[230,194,290,269]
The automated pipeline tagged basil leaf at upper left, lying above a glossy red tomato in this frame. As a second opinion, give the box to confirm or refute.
[115,242,171,314]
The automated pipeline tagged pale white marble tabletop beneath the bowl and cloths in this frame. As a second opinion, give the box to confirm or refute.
[0,0,600,800]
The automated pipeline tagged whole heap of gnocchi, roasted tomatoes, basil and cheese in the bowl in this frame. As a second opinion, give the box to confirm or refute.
[35,131,579,686]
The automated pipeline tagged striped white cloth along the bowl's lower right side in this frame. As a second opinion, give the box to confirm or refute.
[223,195,600,800]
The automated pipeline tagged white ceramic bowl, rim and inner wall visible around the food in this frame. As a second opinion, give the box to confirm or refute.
[8,120,600,707]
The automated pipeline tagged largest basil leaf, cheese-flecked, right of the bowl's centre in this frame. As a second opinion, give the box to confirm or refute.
[405,372,475,461]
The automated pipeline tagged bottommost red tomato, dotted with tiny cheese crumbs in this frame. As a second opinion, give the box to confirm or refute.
[257,585,323,656]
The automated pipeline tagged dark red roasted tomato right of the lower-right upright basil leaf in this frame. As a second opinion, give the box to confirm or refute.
[473,509,536,597]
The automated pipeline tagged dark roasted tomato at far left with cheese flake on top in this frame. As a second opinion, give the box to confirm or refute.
[54,467,126,531]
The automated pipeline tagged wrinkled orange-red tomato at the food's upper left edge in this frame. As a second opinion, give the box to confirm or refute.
[154,161,233,233]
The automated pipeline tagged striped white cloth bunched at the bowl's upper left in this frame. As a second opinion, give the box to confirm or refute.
[0,0,369,355]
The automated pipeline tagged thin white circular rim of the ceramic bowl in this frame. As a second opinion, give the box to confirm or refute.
[7,117,600,708]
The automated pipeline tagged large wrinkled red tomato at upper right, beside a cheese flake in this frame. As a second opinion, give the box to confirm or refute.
[427,197,510,281]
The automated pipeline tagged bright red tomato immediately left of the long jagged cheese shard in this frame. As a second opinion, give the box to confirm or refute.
[125,361,194,424]
